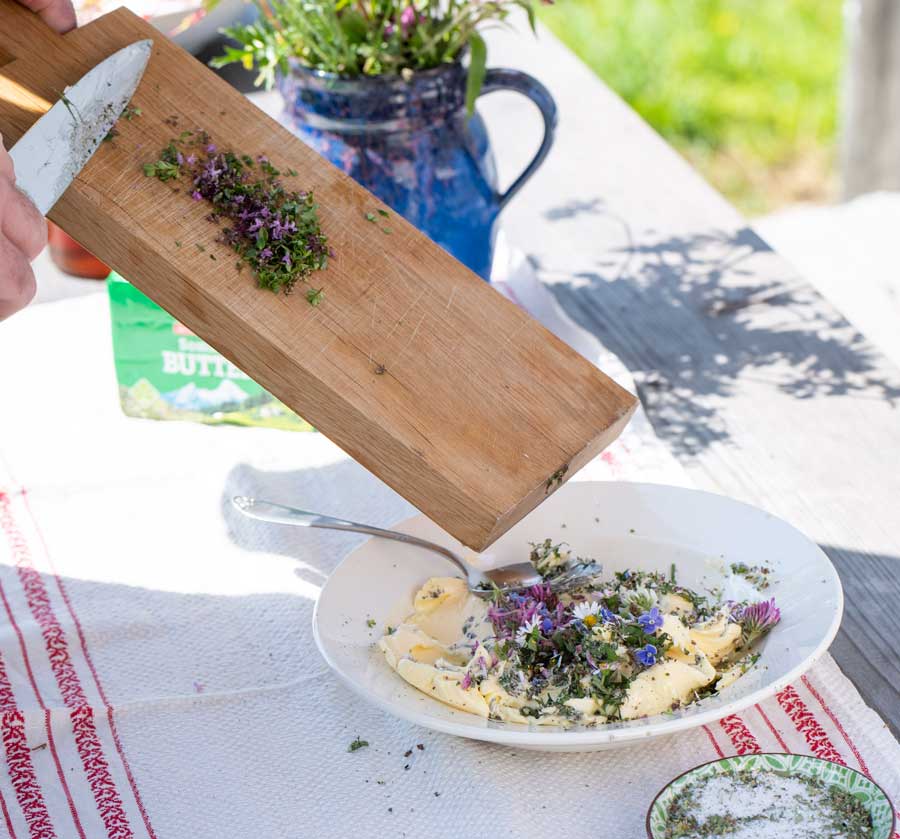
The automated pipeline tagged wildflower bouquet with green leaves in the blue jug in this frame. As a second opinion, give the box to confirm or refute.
[213,0,553,112]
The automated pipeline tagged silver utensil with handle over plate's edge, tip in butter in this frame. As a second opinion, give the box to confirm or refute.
[232,495,599,599]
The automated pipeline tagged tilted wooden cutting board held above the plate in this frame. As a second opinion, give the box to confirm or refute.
[0,0,636,550]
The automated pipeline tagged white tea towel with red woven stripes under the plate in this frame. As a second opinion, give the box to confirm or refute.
[0,254,900,839]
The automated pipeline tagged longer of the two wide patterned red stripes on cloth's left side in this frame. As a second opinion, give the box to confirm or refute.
[0,495,134,839]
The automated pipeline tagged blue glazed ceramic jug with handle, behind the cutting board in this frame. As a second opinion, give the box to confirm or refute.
[278,62,556,279]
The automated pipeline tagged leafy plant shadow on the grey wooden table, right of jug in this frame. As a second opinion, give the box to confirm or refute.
[536,206,900,455]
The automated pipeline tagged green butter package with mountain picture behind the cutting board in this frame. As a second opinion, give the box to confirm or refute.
[107,273,313,431]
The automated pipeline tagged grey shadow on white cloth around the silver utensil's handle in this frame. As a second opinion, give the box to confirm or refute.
[221,459,416,585]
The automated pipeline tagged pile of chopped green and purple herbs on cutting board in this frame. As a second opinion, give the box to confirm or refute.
[144,131,333,298]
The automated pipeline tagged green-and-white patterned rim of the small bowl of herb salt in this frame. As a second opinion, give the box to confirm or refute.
[647,752,896,839]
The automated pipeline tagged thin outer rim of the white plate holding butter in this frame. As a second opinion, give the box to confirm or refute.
[312,480,844,750]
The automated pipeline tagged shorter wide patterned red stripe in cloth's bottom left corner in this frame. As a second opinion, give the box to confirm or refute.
[0,657,56,839]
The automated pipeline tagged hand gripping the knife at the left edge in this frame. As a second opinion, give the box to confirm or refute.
[0,137,47,320]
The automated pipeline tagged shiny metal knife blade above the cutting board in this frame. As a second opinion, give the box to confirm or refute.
[10,40,153,215]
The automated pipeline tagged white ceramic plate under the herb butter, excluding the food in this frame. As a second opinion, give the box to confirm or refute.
[313,481,843,751]
